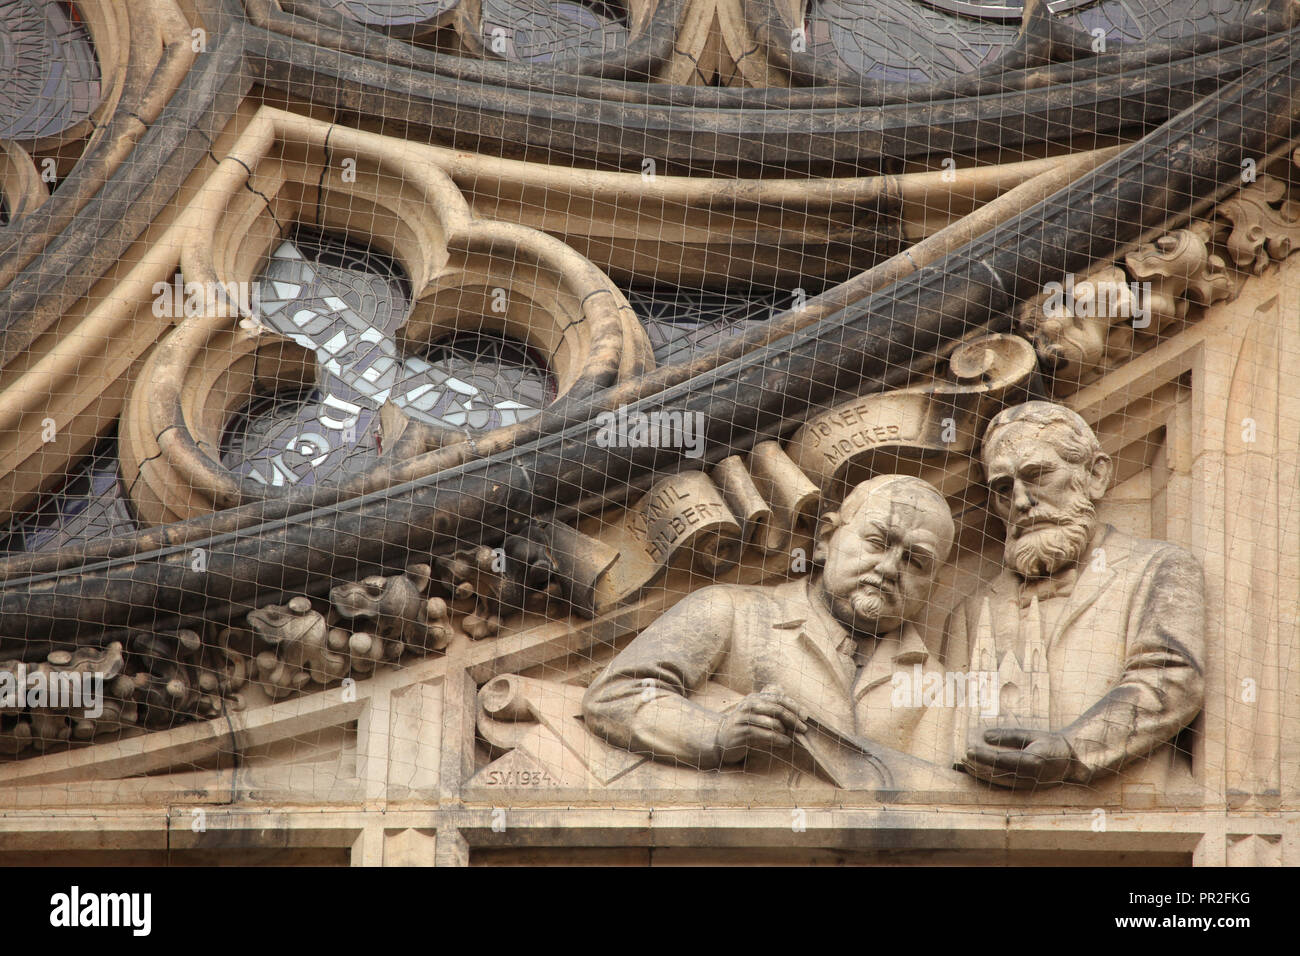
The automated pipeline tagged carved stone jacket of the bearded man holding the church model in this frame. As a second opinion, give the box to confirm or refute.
[944,524,1205,783]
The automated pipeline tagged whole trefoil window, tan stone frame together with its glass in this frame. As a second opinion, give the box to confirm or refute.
[101,109,653,527]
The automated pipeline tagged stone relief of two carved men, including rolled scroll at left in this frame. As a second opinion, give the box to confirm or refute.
[480,401,1205,795]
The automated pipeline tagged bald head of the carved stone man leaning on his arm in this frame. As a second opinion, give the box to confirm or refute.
[813,475,953,633]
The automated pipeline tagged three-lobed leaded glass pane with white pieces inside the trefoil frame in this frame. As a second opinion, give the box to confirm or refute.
[244,228,556,486]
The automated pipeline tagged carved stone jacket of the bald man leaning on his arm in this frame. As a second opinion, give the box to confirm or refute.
[582,580,930,767]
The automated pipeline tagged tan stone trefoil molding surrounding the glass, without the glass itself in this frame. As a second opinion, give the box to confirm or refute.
[120,109,654,524]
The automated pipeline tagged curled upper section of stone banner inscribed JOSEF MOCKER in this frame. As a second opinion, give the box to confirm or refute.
[787,334,1036,497]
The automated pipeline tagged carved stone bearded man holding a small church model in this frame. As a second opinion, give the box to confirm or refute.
[946,402,1205,787]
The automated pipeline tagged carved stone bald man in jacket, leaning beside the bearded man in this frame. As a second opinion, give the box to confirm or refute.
[582,475,953,769]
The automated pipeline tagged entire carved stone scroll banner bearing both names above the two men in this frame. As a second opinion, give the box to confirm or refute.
[543,334,1037,615]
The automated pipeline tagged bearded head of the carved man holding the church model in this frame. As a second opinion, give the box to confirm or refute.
[983,402,1113,578]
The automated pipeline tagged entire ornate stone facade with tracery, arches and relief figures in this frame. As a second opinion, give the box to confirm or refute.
[0,0,1300,866]
